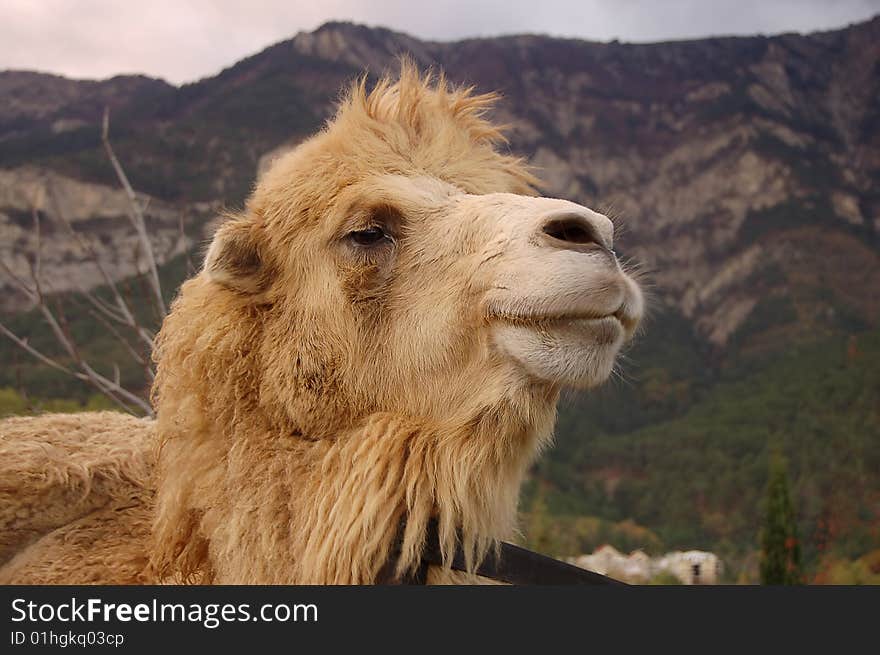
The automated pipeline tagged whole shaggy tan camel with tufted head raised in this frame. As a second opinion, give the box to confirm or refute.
[0,64,643,584]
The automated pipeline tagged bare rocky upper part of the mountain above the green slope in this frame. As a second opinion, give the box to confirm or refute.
[0,18,880,348]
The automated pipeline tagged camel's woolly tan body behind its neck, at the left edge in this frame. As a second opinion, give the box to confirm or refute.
[0,412,153,584]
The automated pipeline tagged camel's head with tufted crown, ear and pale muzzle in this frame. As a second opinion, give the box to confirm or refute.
[192,67,642,438]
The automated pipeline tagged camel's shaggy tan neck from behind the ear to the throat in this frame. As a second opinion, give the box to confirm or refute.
[144,278,556,584]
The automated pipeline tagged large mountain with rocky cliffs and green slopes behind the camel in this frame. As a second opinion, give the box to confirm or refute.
[0,17,880,580]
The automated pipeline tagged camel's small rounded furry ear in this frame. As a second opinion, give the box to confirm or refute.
[204,218,269,294]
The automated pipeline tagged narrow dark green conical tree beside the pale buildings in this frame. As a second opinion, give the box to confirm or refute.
[761,455,803,585]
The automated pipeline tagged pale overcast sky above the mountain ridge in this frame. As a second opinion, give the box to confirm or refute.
[0,0,880,84]
